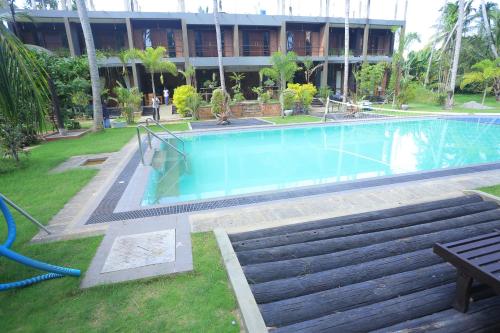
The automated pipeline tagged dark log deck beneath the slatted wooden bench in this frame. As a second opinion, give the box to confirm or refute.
[229,195,500,332]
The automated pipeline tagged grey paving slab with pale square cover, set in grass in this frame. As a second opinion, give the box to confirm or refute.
[80,216,193,288]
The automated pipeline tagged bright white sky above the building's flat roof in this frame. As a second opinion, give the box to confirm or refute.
[21,0,494,49]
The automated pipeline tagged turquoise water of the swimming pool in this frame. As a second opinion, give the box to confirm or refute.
[142,119,500,205]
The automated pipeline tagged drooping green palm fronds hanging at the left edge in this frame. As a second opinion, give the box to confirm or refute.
[0,10,50,160]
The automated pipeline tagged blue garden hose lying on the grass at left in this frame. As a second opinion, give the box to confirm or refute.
[0,197,80,291]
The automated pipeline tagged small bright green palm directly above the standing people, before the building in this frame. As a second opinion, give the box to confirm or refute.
[125,46,177,102]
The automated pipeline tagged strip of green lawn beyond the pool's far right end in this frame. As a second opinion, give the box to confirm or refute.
[377,94,500,115]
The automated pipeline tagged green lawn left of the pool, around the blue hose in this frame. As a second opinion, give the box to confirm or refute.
[0,124,239,332]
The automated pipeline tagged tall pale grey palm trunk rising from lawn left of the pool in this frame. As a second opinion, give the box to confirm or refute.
[75,0,104,131]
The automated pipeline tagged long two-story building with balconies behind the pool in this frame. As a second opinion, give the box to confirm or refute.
[12,10,404,98]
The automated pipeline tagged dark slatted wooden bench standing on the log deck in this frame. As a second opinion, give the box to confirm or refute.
[434,230,500,312]
